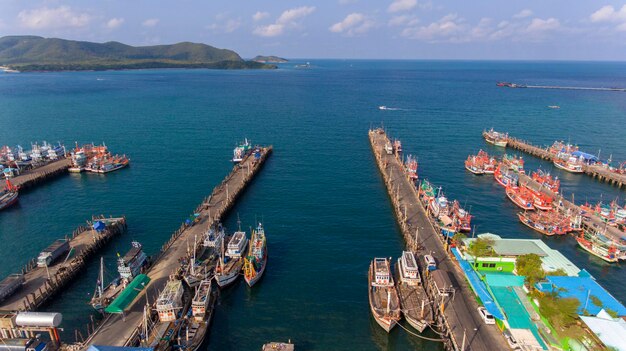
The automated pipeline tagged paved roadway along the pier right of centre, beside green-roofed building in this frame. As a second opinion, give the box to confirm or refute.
[370,133,508,351]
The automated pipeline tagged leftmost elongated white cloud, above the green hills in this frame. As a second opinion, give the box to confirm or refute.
[17,6,91,29]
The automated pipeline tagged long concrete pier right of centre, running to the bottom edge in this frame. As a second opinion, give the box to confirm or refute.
[369,129,508,351]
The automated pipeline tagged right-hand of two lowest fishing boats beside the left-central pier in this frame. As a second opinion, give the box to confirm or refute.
[177,279,215,351]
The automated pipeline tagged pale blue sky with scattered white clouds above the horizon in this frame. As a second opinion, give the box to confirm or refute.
[0,0,626,61]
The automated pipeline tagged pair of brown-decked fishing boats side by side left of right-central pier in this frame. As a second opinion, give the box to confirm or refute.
[368,251,434,333]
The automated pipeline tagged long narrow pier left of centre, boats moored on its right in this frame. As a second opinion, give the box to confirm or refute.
[81,146,272,349]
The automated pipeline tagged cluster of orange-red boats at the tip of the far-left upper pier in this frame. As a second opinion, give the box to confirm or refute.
[69,143,130,173]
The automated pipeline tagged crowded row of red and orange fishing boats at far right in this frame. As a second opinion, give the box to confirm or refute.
[465,150,626,262]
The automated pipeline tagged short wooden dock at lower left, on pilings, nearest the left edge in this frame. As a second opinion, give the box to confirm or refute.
[0,217,126,312]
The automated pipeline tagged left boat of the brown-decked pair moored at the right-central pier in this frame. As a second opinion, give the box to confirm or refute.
[367,258,401,332]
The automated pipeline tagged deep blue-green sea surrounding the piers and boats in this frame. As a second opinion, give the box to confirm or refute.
[0,59,626,350]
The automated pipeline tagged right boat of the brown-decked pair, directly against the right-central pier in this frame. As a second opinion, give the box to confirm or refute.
[396,251,433,333]
